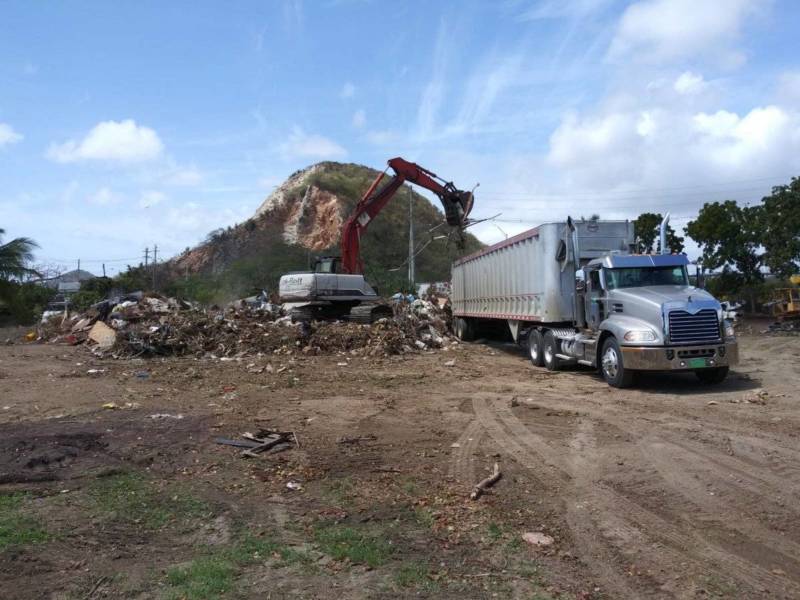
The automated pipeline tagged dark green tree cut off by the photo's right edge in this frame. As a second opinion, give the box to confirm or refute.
[760,177,800,279]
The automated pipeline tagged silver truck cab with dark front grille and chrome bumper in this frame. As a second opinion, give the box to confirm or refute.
[576,253,738,385]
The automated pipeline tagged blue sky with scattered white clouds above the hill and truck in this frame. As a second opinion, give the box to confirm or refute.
[0,0,800,274]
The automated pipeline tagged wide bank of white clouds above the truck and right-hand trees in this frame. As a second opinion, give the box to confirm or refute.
[547,98,800,192]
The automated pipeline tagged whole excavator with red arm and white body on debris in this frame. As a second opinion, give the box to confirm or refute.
[279,157,474,323]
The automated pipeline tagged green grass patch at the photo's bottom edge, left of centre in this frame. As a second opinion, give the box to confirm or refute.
[167,556,236,600]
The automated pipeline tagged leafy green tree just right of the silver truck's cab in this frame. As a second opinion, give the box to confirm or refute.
[686,200,764,310]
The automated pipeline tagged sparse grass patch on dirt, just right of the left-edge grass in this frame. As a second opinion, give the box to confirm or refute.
[89,473,211,529]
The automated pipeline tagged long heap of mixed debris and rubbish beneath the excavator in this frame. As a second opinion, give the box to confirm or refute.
[38,294,451,358]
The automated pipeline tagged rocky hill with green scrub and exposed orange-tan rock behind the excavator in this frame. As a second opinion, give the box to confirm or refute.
[165,162,481,301]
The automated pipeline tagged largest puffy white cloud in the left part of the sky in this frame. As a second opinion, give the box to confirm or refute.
[46,119,164,163]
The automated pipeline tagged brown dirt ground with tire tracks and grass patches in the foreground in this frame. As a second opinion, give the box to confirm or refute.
[0,328,800,599]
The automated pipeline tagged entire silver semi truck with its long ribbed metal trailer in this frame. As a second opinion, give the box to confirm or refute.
[451,216,739,388]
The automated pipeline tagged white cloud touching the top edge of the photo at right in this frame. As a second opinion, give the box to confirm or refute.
[608,0,767,67]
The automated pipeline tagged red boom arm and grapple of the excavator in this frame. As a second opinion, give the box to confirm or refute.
[342,157,473,273]
